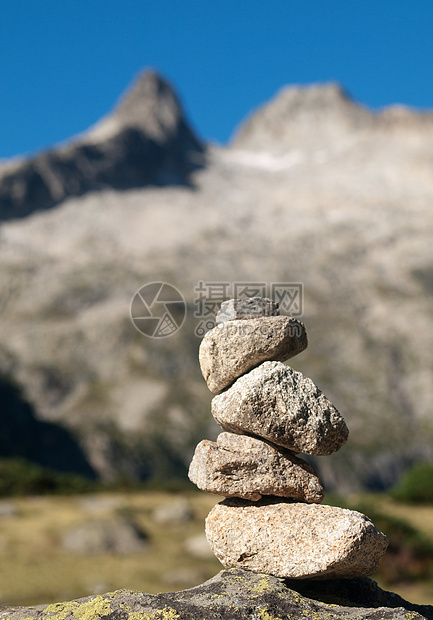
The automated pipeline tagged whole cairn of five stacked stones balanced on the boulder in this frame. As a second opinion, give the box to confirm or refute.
[189,297,388,579]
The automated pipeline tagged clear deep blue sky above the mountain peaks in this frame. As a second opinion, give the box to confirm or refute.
[0,0,433,158]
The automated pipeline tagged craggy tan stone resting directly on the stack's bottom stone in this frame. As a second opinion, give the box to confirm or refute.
[189,433,323,503]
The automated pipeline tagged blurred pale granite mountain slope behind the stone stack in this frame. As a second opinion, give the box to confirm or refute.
[0,72,433,490]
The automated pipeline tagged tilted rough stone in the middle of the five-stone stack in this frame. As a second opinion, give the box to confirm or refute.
[212,362,349,455]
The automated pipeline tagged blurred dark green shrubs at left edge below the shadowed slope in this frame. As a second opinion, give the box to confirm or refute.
[0,458,96,497]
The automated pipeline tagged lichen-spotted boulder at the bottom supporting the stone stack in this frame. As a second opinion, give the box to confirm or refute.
[0,569,433,620]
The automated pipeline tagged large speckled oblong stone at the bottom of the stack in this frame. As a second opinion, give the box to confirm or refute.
[206,499,388,579]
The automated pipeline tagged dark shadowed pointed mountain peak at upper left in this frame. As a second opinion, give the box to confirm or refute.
[0,71,204,220]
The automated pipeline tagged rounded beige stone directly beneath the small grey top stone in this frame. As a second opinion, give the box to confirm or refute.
[199,316,308,392]
